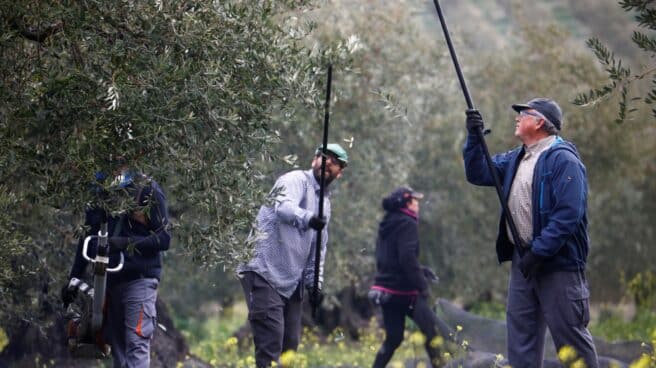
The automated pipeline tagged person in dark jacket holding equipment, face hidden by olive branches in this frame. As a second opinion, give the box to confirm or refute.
[62,166,171,368]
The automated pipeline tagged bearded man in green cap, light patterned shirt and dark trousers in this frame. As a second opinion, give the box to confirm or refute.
[237,143,348,368]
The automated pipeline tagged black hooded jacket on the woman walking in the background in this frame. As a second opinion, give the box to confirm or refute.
[375,205,428,293]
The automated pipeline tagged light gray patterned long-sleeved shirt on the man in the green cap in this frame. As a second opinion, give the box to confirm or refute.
[237,170,330,298]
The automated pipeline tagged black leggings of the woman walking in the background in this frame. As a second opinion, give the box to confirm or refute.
[373,296,450,368]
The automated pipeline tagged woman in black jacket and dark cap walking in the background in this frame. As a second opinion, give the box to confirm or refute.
[370,187,449,368]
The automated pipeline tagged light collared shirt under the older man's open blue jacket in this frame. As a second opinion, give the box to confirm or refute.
[506,135,556,246]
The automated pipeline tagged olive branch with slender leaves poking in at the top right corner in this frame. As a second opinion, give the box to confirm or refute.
[573,0,656,123]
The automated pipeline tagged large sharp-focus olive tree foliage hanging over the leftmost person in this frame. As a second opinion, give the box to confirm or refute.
[0,0,354,334]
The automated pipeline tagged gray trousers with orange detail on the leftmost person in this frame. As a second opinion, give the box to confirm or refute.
[105,278,159,368]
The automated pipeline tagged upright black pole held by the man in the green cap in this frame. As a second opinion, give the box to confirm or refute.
[312,64,333,320]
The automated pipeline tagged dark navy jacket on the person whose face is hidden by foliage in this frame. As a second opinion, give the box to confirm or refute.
[70,180,171,287]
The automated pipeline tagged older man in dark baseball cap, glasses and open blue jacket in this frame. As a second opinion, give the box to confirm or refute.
[463,98,599,368]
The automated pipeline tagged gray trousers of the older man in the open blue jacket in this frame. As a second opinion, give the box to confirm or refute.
[506,251,599,368]
